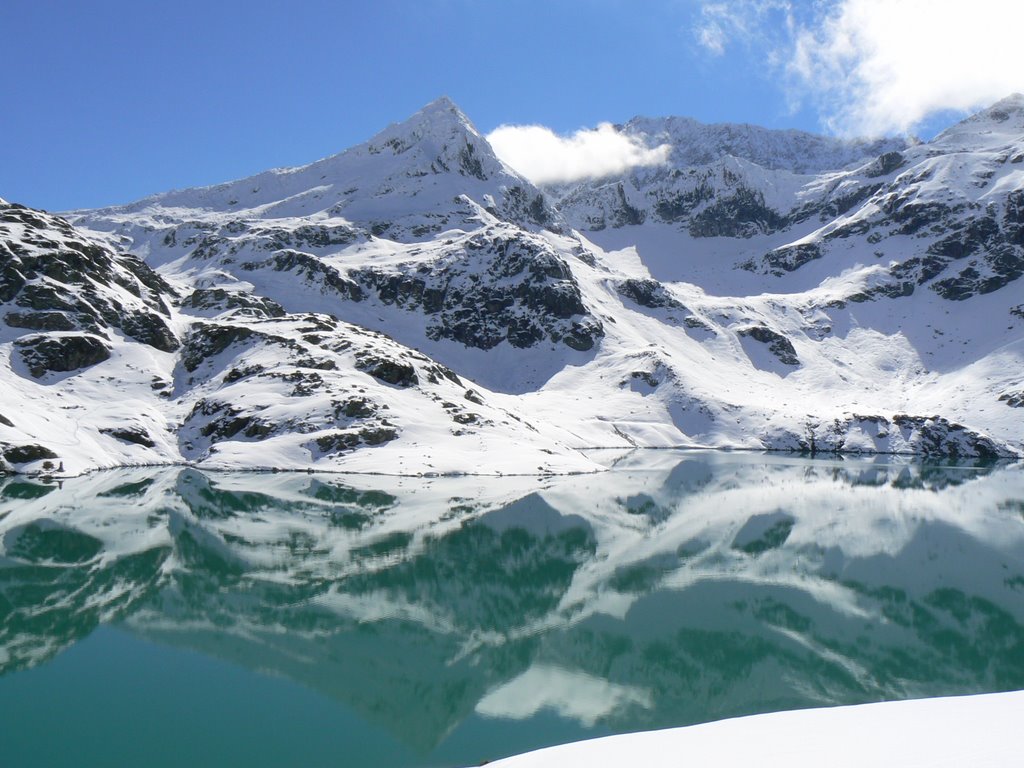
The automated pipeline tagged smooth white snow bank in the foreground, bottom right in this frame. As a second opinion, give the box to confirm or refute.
[490,691,1024,768]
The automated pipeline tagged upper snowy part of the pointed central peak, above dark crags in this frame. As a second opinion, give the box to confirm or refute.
[66,96,560,237]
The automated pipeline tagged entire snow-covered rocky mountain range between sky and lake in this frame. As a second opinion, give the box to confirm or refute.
[0,95,1024,472]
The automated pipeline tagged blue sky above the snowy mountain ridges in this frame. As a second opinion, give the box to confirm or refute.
[0,0,1024,210]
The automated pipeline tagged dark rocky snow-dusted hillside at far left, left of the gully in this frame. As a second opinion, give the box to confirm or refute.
[0,204,179,472]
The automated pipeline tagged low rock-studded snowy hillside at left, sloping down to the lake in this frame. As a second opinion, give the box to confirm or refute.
[0,198,598,474]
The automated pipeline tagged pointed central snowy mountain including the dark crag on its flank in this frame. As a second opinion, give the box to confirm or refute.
[73,99,602,390]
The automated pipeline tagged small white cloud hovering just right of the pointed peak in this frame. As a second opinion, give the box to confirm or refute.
[487,123,671,184]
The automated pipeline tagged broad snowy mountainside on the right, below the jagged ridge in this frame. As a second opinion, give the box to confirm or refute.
[536,96,1024,450]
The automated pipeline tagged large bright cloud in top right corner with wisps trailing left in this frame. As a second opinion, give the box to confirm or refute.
[694,0,1024,135]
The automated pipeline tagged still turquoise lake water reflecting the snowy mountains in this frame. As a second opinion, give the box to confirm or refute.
[0,452,1024,766]
